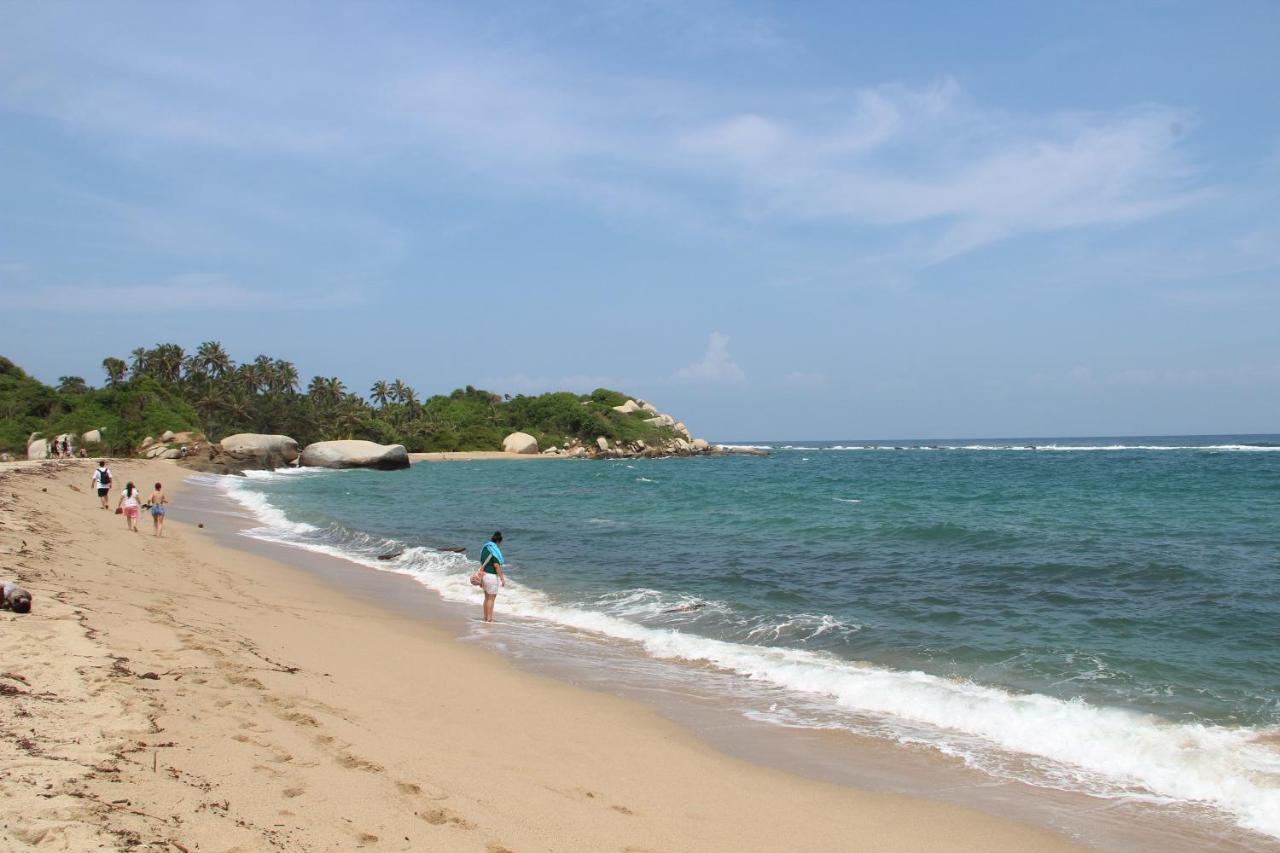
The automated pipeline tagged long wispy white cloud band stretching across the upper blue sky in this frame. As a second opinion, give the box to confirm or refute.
[0,15,1204,265]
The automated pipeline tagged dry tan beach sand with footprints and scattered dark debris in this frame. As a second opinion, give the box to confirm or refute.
[0,461,1071,853]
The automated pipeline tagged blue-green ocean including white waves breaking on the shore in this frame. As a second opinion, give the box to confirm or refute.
[204,435,1280,839]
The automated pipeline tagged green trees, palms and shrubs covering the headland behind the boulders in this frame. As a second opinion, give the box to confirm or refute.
[0,341,676,455]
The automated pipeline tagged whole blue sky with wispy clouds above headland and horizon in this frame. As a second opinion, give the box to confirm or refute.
[0,0,1280,441]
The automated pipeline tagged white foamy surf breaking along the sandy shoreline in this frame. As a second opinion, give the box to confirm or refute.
[221,478,1280,838]
